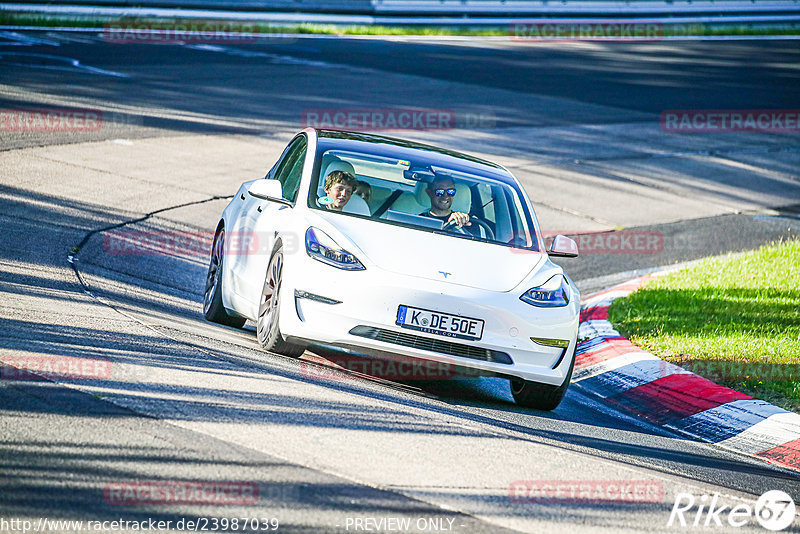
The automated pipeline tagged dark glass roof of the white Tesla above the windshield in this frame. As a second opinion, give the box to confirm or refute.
[317,130,518,185]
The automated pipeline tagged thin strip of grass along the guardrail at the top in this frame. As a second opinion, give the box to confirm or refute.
[0,11,800,37]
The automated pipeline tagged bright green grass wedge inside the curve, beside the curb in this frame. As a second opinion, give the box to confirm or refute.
[609,241,800,411]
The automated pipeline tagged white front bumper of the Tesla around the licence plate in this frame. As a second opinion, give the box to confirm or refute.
[280,256,580,385]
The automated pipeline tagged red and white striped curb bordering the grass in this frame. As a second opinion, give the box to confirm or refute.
[572,275,800,471]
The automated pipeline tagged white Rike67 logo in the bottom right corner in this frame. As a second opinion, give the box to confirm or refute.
[667,490,795,532]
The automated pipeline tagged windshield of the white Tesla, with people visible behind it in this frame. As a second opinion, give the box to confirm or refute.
[309,150,537,250]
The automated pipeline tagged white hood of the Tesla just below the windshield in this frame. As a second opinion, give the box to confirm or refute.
[321,213,547,292]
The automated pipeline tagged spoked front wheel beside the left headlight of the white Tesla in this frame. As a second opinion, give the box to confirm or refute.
[256,243,306,358]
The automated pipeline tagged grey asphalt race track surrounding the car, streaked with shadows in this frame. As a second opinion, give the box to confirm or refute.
[0,32,800,534]
